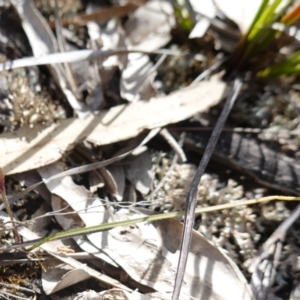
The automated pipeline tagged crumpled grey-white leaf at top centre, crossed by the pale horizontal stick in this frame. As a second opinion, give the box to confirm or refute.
[120,0,175,101]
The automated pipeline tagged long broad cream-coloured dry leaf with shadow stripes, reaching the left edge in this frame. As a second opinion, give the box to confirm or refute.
[0,81,228,175]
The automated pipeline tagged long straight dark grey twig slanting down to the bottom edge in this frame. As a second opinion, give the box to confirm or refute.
[172,78,242,300]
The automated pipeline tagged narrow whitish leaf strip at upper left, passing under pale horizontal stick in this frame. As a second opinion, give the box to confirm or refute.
[11,0,90,118]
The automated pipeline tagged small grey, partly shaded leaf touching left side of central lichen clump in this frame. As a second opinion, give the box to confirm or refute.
[124,151,154,195]
